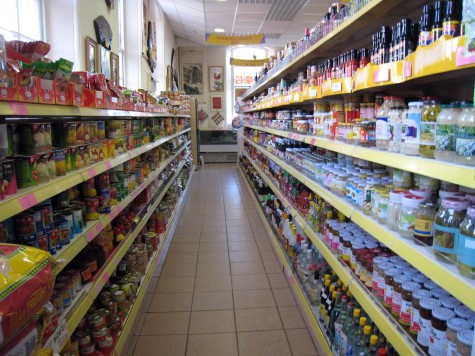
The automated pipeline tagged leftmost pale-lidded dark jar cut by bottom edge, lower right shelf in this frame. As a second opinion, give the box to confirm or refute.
[429,307,455,356]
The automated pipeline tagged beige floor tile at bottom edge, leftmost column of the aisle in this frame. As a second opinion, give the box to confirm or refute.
[134,335,187,356]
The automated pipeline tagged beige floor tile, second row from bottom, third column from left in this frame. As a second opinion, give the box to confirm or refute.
[235,308,282,332]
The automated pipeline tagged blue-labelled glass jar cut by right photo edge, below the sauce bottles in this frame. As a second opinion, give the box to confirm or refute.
[455,104,475,166]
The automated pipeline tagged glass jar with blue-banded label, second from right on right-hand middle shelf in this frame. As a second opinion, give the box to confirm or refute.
[433,198,468,262]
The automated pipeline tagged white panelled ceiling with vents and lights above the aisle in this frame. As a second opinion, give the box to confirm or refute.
[158,0,334,48]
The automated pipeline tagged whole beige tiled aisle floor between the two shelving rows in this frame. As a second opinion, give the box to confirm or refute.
[127,164,317,356]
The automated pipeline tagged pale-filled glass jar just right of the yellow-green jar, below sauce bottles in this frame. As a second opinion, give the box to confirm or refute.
[434,104,461,162]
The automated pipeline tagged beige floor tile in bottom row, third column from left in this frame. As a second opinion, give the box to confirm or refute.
[238,330,292,356]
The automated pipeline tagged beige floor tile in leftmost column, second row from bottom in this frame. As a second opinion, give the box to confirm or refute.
[142,312,190,335]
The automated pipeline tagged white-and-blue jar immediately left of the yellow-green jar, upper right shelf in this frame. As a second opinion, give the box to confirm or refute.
[401,101,424,156]
